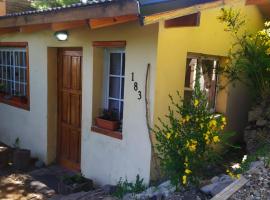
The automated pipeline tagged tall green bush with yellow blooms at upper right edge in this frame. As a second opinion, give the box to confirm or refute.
[218,8,270,98]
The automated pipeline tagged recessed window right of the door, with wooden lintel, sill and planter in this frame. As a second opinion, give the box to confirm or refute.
[91,41,126,140]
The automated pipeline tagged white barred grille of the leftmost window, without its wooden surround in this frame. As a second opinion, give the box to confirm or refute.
[0,47,27,96]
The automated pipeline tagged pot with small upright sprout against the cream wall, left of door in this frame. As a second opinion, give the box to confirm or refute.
[13,138,31,170]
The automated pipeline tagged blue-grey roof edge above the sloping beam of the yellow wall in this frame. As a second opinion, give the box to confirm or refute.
[140,0,217,16]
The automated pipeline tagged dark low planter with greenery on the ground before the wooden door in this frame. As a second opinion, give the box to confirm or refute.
[58,174,94,195]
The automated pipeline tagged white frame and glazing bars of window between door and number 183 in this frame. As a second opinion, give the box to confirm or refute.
[103,47,126,120]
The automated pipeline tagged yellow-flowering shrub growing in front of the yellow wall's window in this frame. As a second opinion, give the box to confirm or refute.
[154,70,232,186]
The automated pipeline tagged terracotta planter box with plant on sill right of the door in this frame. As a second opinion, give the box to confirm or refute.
[96,109,120,131]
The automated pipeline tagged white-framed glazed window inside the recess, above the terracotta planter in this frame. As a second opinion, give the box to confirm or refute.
[104,49,125,121]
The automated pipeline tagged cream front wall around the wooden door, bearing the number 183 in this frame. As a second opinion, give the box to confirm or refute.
[0,22,158,184]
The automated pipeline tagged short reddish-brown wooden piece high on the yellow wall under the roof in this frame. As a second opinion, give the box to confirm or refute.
[165,12,201,28]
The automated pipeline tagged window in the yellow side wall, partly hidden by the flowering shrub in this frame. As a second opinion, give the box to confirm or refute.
[184,54,219,112]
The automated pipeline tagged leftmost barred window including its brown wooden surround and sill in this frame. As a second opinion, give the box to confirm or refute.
[0,43,29,109]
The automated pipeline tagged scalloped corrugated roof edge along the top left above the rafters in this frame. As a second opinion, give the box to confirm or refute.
[0,0,114,18]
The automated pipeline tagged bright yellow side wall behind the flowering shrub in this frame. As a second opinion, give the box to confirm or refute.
[154,1,263,134]
